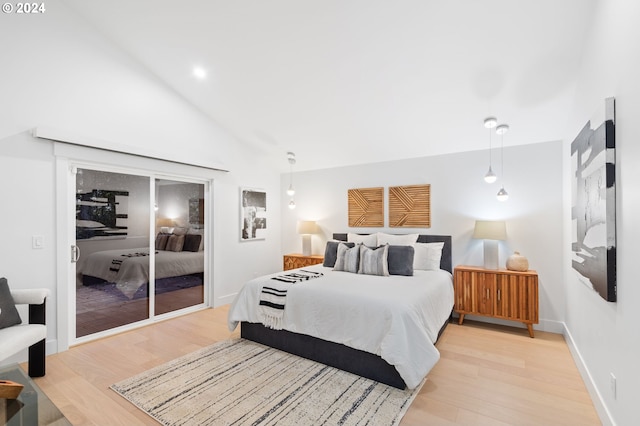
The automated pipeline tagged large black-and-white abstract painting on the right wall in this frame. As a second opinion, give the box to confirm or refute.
[571,98,617,302]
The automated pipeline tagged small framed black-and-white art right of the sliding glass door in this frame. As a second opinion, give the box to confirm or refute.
[240,188,267,241]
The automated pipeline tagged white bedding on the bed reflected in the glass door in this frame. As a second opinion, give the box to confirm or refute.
[79,248,204,298]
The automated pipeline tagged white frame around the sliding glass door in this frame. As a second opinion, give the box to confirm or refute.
[64,158,213,351]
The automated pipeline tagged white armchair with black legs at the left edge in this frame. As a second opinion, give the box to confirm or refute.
[0,289,49,377]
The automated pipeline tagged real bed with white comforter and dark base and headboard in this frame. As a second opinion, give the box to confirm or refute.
[228,234,453,389]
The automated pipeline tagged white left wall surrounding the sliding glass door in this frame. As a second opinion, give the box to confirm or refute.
[0,2,284,363]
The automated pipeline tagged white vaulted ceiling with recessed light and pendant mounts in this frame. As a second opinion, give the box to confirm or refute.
[65,0,594,171]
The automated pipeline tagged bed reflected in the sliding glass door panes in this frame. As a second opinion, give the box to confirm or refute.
[79,247,204,299]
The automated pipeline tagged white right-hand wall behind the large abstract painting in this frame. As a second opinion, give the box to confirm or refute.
[563,0,640,425]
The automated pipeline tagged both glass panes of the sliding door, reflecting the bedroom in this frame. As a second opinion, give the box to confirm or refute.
[74,167,207,339]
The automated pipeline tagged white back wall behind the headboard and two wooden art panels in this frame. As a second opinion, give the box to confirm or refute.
[280,142,564,332]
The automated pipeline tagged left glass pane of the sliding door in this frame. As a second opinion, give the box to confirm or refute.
[75,168,150,337]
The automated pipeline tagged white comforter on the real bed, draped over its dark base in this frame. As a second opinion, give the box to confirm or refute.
[228,265,453,389]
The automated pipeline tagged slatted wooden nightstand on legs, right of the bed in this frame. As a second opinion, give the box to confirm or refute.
[453,266,538,337]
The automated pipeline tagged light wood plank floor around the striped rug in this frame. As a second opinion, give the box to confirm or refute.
[27,306,601,426]
